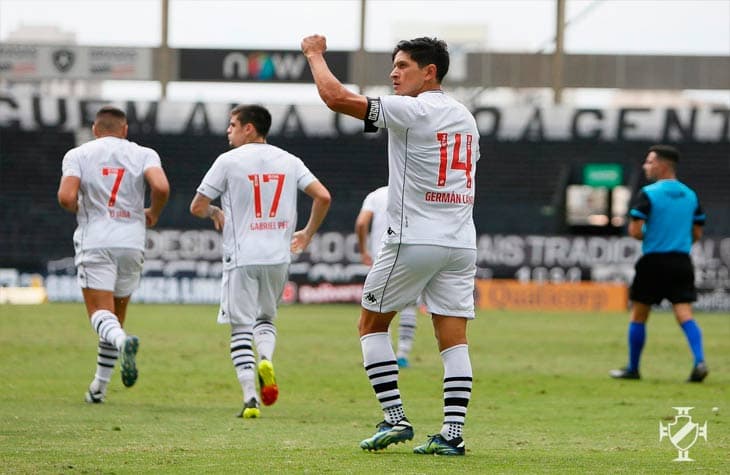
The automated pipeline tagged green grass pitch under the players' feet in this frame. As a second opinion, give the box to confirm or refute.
[0,304,730,474]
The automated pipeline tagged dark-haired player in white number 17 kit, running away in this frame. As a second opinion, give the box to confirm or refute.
[190,105,330,418]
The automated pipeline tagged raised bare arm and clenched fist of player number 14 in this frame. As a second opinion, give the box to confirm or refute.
[302,35,368,120]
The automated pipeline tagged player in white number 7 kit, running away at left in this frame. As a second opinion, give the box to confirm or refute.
[58,106,170,403]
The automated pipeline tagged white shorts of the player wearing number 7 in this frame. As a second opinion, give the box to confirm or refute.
[75,248,144,297]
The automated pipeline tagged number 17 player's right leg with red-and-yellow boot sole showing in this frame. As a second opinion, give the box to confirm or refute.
[253,264,289,406]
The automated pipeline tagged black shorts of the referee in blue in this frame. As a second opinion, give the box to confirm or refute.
[629,252,697,305]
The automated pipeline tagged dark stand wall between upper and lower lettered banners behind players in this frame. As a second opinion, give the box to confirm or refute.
[0,128,730,272]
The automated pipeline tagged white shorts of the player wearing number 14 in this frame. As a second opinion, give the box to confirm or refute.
[362,244,477,318]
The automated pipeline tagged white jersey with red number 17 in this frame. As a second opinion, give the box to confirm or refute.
[198,143,316,269]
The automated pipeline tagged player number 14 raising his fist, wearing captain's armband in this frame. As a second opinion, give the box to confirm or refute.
[302,35,479,455]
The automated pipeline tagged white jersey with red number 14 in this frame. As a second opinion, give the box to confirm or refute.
[371,90,479,249]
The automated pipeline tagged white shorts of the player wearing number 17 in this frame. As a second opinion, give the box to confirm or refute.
[218,263,289,326]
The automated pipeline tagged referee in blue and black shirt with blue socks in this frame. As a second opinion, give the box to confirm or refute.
[610,145,708,383]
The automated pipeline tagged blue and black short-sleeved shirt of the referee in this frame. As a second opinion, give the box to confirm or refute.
[629,180,705,254]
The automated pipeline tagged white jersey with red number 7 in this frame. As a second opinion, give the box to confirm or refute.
[62,137,162,254]
